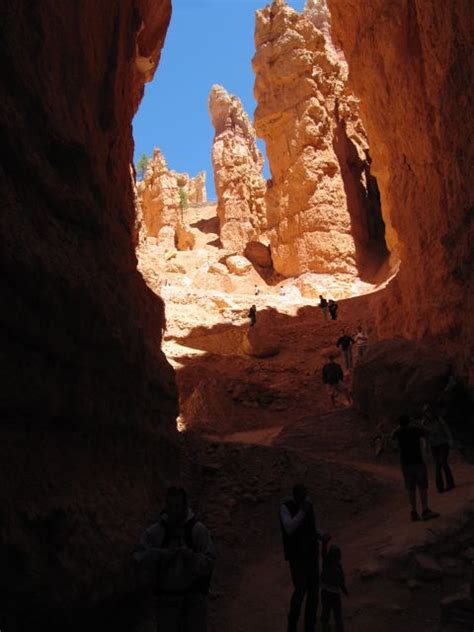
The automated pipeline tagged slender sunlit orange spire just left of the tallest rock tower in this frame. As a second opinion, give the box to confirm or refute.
[209,85,266,254]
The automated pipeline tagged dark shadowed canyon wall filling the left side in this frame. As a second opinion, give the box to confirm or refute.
[0,0,178,631]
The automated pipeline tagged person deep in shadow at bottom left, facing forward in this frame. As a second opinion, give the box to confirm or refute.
[134,487,216,632]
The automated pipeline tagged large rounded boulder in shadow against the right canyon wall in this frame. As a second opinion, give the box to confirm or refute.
[353,337,450,420]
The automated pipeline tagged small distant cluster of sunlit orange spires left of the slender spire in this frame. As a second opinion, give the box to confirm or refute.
[136,148,207,250]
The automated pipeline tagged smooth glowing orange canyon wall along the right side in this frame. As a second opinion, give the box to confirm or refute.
[329,0,474,376]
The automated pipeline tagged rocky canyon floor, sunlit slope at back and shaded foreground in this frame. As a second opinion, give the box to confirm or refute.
[135,205,474,632]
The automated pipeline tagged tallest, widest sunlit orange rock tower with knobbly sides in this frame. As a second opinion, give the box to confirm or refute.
[253,1,384,276]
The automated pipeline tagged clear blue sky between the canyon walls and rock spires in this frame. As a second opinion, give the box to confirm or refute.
[133,0,305,199]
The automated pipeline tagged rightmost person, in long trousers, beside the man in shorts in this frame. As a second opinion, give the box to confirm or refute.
[422,404,454,494]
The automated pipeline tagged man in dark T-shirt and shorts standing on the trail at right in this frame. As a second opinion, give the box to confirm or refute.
[392,415,439,522]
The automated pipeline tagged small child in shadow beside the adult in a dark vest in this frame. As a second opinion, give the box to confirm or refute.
[321,537,348,632]
